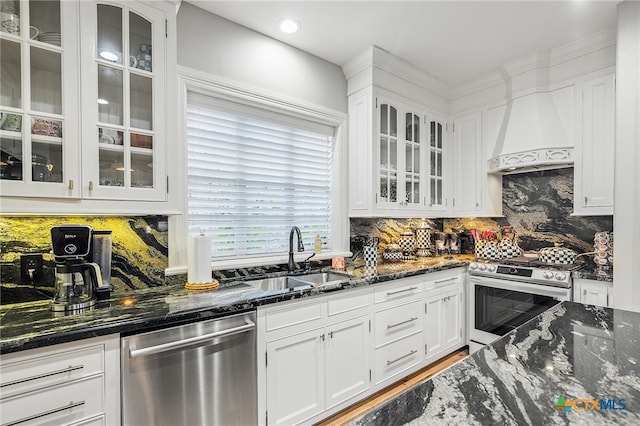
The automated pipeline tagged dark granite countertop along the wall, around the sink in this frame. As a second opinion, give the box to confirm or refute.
[0,255,473,353]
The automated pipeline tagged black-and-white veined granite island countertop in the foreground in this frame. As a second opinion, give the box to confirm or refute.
[350,302,640,426]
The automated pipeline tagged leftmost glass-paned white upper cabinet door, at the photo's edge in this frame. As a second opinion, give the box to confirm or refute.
[0,0,80,198]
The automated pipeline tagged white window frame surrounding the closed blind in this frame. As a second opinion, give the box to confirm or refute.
[165,66,351,275]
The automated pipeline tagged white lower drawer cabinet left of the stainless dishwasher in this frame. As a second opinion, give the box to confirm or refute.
[0,335,120,425]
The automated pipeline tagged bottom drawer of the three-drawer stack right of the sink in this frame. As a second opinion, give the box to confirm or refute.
[374,333,424,385]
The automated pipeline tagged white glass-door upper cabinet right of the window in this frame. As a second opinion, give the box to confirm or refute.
[349,89,452,217]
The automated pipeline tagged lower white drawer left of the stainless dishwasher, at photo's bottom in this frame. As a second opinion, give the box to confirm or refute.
[0,375,105,425]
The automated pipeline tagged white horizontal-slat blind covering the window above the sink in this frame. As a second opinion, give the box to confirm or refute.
[186,93,334,260]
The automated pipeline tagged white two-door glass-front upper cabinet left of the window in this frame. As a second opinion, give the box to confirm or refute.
[0,0,168,205]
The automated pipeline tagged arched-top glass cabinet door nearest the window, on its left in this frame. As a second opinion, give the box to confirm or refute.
[80,2,165,200]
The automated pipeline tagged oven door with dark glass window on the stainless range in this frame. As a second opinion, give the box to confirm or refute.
[468,275,571,352]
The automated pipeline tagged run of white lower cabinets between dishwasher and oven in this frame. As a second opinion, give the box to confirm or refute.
[258,268,466,425]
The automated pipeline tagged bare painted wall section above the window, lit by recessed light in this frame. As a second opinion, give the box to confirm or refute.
[178,2,347,112]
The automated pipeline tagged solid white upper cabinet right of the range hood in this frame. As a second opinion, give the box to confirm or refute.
[574,73,615,215]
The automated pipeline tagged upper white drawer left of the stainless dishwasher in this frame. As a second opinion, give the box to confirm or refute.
[0,345,104,399]
